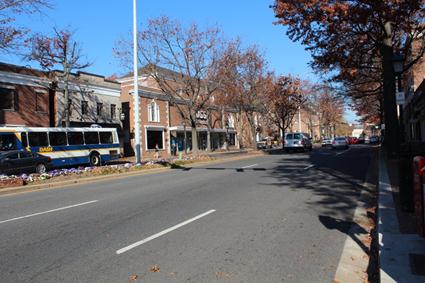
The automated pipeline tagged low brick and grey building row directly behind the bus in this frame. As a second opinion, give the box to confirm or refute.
[0,63,121,136]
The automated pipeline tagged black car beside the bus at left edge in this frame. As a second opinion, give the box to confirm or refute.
[0,150,51,175]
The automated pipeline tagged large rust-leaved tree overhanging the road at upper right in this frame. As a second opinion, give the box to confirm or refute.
[273,0,425,155]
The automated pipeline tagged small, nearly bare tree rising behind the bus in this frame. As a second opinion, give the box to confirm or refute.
[27,29,91,127]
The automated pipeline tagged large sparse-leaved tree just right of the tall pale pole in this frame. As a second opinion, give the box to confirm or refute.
[114,17,223,154]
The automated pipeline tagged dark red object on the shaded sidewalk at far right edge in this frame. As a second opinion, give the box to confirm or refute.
[413,156,425,237]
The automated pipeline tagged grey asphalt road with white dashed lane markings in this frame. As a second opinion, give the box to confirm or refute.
[0,146,377,282]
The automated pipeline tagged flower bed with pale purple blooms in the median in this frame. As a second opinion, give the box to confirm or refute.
[0,156,214,191]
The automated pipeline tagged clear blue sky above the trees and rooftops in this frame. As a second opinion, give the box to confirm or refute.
[4,0,354,123]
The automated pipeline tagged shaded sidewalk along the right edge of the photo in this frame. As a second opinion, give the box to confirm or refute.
[378,152,425,283]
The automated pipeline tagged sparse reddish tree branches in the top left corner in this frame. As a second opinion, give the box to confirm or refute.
[0,0,50,53]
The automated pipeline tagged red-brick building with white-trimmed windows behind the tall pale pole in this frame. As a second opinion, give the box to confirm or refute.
[119,69,238,157]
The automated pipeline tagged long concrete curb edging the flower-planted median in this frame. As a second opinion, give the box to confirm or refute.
[0,153,263,197]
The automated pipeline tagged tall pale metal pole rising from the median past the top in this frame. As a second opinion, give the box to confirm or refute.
[133,0,141,164]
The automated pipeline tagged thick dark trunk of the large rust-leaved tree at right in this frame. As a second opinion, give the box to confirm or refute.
[381,22,399,156]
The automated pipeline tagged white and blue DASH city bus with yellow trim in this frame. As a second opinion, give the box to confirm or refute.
[0,127,120,167]
